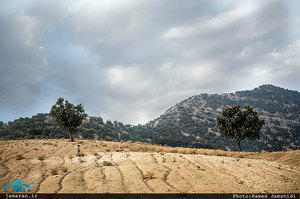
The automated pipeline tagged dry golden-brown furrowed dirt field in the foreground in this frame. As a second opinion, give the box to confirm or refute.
[0,140,300,193]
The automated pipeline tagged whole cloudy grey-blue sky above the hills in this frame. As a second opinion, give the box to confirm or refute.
[0,0,300,124]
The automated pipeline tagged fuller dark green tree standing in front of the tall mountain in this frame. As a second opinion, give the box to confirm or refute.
[217,105,265,151]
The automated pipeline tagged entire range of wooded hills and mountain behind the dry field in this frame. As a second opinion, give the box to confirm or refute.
[0,85,300,151]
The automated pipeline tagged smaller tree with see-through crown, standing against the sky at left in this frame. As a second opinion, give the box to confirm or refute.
[50,98,87,141]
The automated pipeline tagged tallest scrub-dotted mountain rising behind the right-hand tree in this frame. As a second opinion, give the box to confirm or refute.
[134,85,300,151]
